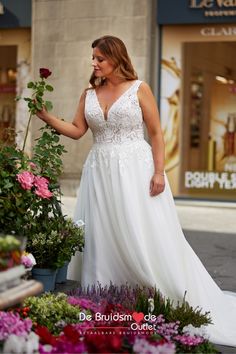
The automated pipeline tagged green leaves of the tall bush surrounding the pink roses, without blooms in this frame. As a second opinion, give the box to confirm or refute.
[0,126,65,236]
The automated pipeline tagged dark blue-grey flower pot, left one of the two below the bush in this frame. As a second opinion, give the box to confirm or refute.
[31,267,57,291]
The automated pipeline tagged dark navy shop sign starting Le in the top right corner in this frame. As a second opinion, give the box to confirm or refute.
[157,0,236,25]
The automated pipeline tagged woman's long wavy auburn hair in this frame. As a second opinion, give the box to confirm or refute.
[89,36,138,88]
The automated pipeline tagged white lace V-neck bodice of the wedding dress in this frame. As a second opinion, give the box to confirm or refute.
[85,80,144,144]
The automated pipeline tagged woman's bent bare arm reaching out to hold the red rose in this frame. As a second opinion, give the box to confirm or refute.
[36,92,88,139]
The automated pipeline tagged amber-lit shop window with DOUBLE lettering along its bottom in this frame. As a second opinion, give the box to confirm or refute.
[180,42,236,199]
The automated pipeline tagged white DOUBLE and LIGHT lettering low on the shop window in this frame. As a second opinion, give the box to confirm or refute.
[185,171,236,190]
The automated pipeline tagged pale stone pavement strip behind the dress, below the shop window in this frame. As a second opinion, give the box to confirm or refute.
[62,196,236,236]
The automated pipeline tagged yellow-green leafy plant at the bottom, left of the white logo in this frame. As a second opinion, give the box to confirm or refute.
[23,293,80,334]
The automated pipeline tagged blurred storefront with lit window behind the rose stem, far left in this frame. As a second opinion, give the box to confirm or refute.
[0,0,31,147]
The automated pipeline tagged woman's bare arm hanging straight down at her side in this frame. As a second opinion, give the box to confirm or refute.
[138,82,165,196]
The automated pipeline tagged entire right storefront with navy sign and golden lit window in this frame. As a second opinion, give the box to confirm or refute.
[157,0,236,201]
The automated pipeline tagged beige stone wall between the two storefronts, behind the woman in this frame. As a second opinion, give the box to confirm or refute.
[32,0,156,195]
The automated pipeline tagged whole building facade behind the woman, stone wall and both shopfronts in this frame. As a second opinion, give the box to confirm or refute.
[0,0,236,201]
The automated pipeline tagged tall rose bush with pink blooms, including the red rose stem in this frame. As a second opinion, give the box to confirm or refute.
[0,69,62,235]
